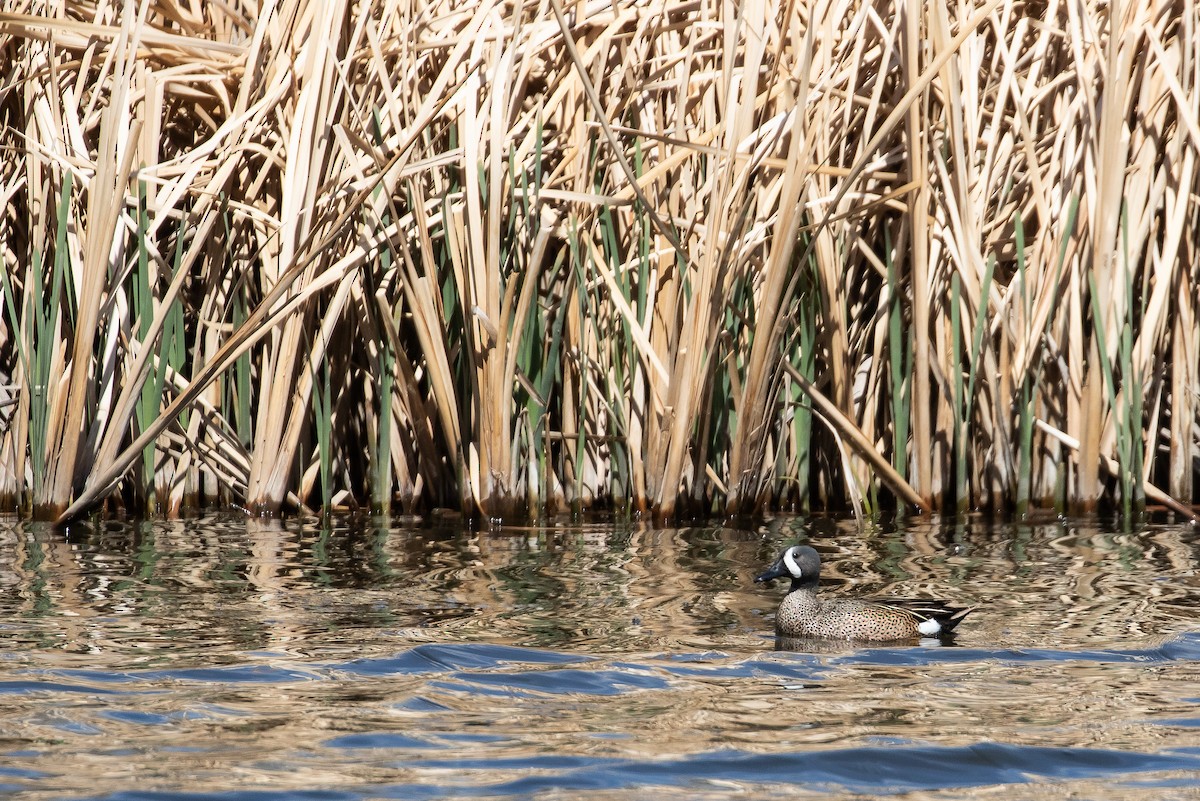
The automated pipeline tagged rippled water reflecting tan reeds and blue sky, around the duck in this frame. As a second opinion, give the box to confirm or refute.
[0,517,1200,801]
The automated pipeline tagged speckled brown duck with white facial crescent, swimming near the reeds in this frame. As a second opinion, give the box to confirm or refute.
[755,546,971,643]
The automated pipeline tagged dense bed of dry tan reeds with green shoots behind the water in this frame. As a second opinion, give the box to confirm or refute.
[0,0,1200,519]
